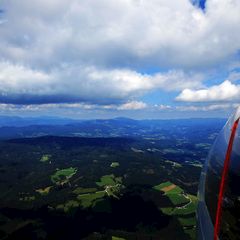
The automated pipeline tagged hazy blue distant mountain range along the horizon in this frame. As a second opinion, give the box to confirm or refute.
[0,116,226,139]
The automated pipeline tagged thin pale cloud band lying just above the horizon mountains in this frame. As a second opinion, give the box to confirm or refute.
[0,101,240,116]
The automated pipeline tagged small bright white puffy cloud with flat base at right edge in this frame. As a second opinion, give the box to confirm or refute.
[176,80,240,102]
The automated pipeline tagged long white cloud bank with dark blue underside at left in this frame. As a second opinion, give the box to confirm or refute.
[0,62,202,104]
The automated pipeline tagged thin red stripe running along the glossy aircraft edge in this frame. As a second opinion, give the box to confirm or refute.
[214,119,239,240]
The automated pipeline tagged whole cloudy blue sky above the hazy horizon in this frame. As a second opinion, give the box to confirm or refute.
[0,0,240,119]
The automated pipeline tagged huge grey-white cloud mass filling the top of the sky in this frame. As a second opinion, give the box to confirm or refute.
[0,0,240,68]
